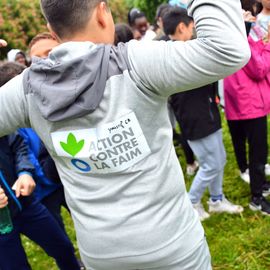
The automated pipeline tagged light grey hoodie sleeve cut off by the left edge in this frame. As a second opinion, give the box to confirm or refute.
[0,73,30,137]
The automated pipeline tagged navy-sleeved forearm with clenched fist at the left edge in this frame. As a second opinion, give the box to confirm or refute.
[8,132,36,197]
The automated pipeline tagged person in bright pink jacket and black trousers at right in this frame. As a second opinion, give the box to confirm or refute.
[224,16,270,215]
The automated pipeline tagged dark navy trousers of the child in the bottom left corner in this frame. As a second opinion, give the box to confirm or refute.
[0,197,80,270]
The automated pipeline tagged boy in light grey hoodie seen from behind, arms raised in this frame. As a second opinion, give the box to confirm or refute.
[0,0,250,270]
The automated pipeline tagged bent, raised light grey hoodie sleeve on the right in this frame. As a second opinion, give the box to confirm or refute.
[128,0,250,97]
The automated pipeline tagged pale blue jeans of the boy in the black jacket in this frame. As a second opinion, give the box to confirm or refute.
[188,129,226,204]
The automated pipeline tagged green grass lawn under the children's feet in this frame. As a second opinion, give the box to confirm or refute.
[23,111,270,270]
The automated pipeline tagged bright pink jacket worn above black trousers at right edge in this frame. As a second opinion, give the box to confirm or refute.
[224,37,270,120]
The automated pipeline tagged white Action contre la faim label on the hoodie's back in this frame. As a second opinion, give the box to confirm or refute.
[51,112,151,174]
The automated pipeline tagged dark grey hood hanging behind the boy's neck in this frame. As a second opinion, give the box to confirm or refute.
[24,42,129,122]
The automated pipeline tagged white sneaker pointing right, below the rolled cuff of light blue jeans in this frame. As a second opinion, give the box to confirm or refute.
[208,197,244,214]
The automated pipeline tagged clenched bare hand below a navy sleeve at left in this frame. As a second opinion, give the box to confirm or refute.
[13,174,36,198]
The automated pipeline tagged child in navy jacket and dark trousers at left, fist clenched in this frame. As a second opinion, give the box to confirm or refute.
[0,63,80,270]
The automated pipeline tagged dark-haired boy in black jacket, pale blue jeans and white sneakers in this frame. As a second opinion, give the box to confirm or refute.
[163,7,243,220]
